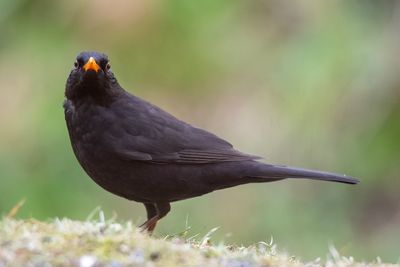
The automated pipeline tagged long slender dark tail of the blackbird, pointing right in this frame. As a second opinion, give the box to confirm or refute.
[253,164,359,184]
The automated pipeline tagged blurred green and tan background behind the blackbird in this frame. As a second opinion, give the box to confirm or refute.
[0,0,400,261]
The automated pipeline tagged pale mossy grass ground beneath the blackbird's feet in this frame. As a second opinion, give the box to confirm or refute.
[0,211,400,267]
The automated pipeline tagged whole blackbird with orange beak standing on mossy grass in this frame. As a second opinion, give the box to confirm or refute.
[63,51,359,233]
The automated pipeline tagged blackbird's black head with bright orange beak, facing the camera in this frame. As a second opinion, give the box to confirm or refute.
[65,52,121,100]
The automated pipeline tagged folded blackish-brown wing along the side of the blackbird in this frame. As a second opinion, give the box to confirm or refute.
[109,94,260,164]
